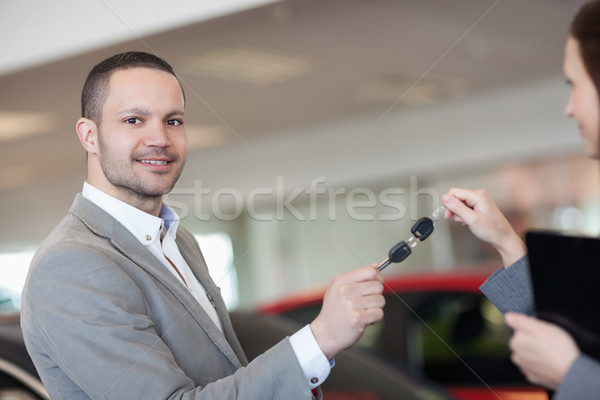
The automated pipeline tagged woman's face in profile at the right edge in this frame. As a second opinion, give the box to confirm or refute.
[563,38,600,158]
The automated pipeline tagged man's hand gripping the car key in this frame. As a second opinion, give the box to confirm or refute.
[310,264,385,360]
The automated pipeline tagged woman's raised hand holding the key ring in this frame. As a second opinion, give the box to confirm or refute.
[442,188,527,267]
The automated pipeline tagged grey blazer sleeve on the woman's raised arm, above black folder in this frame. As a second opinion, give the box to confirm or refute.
[479,256,535,315]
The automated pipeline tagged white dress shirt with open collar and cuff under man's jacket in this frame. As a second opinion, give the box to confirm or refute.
[81,182,334,389]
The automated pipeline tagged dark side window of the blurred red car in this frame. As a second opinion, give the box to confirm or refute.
[278,292,527,385]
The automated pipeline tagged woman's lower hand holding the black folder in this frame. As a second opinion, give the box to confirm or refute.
[505,313,580,389]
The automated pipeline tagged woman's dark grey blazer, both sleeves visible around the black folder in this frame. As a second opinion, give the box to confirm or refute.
[480,257,600,400]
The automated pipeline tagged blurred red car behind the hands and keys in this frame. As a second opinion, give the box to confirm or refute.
[259,268,548,400]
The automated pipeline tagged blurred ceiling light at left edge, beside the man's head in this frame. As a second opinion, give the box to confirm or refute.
[0,111,58,142]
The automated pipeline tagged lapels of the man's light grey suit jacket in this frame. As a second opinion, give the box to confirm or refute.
[70,195,245,367]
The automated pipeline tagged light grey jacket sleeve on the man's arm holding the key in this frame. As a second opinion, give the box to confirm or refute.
[21,246,314,400]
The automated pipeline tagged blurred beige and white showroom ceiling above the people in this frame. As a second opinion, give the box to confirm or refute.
[0,0,582,242]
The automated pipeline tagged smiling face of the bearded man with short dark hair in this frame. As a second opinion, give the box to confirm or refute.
[95,68,187,204]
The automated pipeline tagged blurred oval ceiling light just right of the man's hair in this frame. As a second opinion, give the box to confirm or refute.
[178,46,315,86]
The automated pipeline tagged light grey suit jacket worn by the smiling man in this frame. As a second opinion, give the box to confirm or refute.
[21,195,313,400]
